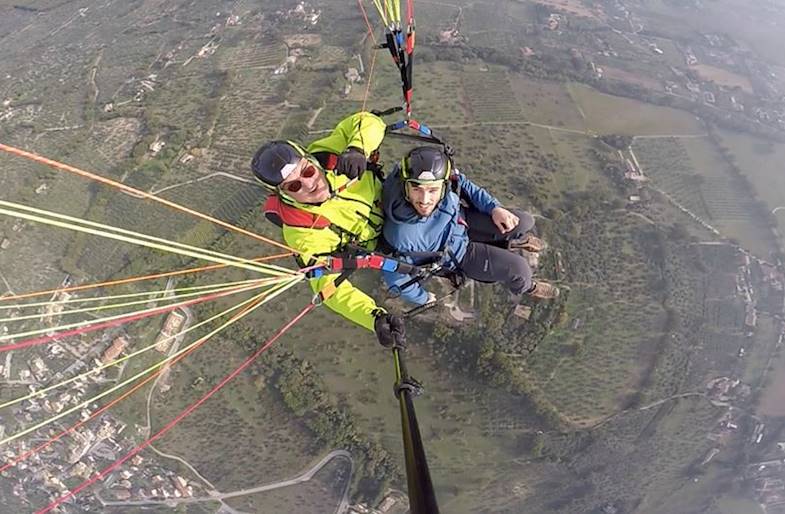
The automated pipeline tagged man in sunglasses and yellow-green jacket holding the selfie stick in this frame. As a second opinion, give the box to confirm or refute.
[251,112,404,346]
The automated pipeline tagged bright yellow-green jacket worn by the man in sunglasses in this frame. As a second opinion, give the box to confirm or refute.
[283,112,385,330]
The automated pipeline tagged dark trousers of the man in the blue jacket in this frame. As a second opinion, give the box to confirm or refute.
[461,209,534,294]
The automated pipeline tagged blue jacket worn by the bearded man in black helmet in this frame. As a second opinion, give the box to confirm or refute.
[382,166,501,305]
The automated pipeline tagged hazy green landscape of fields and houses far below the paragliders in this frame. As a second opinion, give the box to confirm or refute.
[0,0,785,514]
